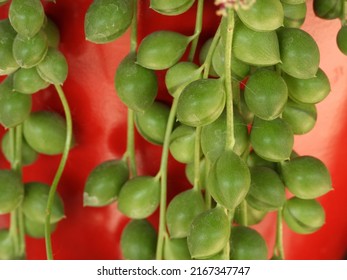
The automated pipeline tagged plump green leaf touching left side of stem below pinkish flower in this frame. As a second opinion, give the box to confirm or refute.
[177,79,225,127]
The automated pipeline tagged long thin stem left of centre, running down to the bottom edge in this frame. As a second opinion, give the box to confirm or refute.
[156,98,178,260]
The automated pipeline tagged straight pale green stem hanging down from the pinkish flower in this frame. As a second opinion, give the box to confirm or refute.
[223,9,235,150]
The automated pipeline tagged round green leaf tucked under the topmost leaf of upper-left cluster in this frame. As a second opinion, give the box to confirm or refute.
[12,32,48,68]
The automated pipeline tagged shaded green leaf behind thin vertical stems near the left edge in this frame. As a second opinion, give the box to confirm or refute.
[1,132,38,165]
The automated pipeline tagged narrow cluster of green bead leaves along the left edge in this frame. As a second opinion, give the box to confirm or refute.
[0,0,72,259]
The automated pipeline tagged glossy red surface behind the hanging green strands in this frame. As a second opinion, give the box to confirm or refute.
[0,0,347,259]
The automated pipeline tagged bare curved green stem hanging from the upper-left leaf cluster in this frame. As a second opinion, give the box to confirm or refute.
[45,84,72,260]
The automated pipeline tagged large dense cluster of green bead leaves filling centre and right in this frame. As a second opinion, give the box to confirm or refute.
[84,0,332,259]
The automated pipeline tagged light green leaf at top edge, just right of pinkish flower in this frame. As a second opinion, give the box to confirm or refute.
[237,0,284,31]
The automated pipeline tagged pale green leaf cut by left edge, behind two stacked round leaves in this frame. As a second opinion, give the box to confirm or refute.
[0,19,19,76]
